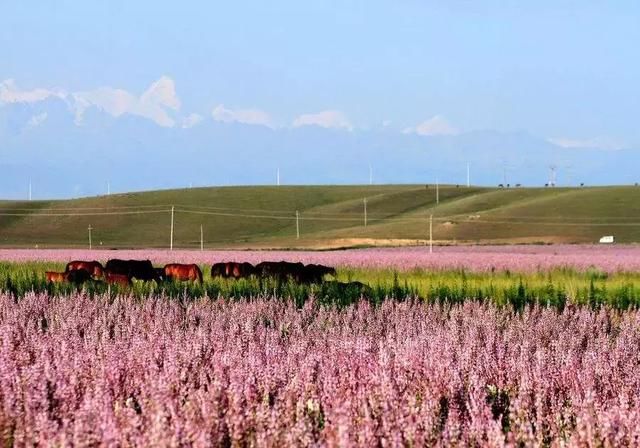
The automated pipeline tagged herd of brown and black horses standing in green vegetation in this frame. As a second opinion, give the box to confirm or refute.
[45,259,336,286]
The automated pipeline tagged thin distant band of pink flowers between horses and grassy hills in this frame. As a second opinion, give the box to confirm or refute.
[0,245,640,272]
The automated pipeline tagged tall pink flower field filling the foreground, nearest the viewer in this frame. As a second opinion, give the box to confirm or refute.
[0,294,640,447]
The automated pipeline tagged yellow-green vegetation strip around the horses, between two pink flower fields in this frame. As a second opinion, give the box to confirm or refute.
[0,262,640,309]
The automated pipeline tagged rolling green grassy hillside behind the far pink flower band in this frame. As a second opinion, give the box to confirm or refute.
[0,185,640,248]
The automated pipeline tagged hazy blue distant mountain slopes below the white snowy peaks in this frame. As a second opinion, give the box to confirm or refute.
[0,95,640,198]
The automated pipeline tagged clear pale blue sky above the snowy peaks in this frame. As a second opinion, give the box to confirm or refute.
[0,0,640,146]
